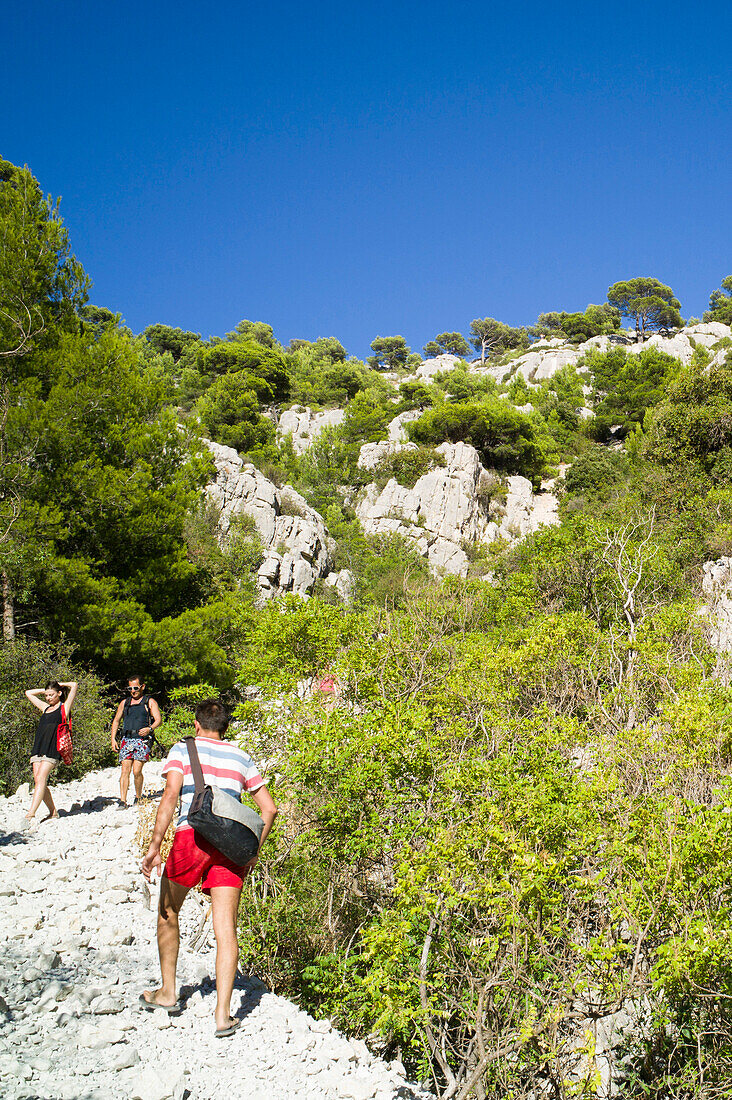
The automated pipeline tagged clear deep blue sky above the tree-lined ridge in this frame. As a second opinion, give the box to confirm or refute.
[0,0,732,355]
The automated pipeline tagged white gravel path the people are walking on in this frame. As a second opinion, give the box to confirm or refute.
[0,765,429,1100]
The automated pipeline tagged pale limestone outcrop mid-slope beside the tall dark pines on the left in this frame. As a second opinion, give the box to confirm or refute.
[207,442,330,600]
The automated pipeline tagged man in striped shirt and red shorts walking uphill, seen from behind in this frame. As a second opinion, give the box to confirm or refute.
[140,700,277,1038]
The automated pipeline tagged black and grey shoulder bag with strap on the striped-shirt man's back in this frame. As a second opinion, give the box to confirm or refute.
[185,737,264,867]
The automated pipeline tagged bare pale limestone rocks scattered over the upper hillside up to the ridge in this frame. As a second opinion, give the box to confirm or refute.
[202,322,732,601]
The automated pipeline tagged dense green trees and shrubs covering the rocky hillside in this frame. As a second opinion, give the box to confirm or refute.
[0,162,732,1100]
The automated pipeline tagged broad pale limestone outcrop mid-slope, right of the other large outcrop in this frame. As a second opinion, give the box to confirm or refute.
[356,443,557,576]
